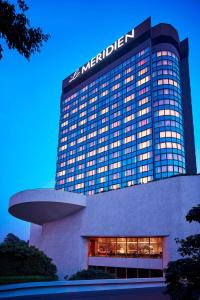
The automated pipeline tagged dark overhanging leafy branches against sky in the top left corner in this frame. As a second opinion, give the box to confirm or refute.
[0,0,50,60]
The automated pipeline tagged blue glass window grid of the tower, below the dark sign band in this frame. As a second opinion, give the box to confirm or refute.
[56,47,185,195]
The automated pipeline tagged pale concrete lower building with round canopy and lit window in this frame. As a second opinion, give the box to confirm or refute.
[9,175,200,278]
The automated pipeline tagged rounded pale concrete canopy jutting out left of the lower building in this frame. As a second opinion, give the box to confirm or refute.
[9,189,86,225]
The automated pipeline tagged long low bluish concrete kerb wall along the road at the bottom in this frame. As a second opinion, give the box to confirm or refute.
[0,277,165,298]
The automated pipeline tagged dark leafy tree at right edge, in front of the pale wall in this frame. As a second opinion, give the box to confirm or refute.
[166,205,200,300]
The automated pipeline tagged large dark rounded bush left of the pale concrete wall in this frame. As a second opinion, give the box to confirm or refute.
[0,233,57,279]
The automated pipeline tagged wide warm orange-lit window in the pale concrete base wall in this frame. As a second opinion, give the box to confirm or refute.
[89,237,163,258]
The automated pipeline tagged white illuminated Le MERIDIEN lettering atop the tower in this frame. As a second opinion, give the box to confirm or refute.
[68,29,135,83]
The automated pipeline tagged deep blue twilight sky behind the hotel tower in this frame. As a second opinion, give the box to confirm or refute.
[0,0,200,240]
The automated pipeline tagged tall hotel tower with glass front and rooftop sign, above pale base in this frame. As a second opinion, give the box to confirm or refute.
[56,18,196,195]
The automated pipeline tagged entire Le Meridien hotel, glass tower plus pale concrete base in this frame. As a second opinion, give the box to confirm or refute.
[9,18,200,278]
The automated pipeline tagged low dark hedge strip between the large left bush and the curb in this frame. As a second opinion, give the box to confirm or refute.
[0,275,58,285]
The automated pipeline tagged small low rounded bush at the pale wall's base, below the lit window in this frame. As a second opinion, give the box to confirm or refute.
[68,269,116,280]
